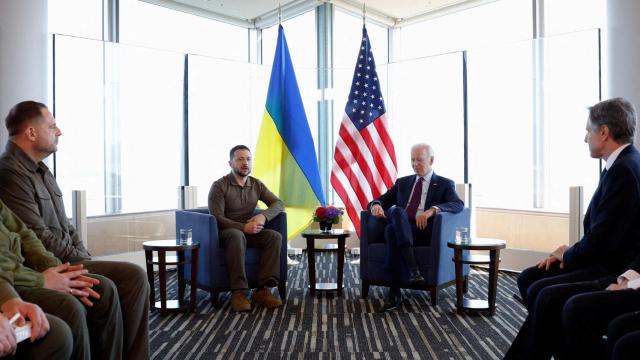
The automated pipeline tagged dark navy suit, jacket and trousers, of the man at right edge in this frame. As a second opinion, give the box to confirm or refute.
[505,145,640,359]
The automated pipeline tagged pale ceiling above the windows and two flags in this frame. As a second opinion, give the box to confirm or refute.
[141,0,495,28]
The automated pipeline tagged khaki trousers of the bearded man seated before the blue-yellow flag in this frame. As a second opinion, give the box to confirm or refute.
[220,229,282,290]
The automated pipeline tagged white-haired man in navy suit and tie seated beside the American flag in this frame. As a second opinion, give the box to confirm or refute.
[367,144,464,311]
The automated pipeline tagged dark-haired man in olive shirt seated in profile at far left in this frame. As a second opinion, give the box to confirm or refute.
[0,101,150,359]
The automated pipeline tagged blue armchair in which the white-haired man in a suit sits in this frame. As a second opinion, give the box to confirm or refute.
[360,208,470,306]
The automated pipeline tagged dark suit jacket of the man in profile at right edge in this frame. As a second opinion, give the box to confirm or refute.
[563,145,640,274]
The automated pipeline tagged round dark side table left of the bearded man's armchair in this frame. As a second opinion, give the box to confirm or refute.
[142,240,200,314]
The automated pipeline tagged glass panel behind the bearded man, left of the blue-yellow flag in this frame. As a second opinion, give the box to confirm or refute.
[189,55,270,206]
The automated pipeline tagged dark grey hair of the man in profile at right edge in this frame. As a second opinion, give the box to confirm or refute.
[589,98,636,144]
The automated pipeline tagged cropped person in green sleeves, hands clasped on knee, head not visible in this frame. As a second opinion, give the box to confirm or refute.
[0,197,122,359]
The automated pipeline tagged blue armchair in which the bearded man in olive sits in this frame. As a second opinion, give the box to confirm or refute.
[176,208,287,307]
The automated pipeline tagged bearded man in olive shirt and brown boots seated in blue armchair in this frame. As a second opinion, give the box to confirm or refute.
[209,145,286,311]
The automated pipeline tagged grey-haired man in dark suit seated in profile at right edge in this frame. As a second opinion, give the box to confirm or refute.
[506,98,640,359]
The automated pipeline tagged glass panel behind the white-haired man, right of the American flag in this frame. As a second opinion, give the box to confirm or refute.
[387,52,464,182]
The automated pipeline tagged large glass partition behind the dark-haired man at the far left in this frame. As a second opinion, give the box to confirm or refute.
[54,35,184,216]
